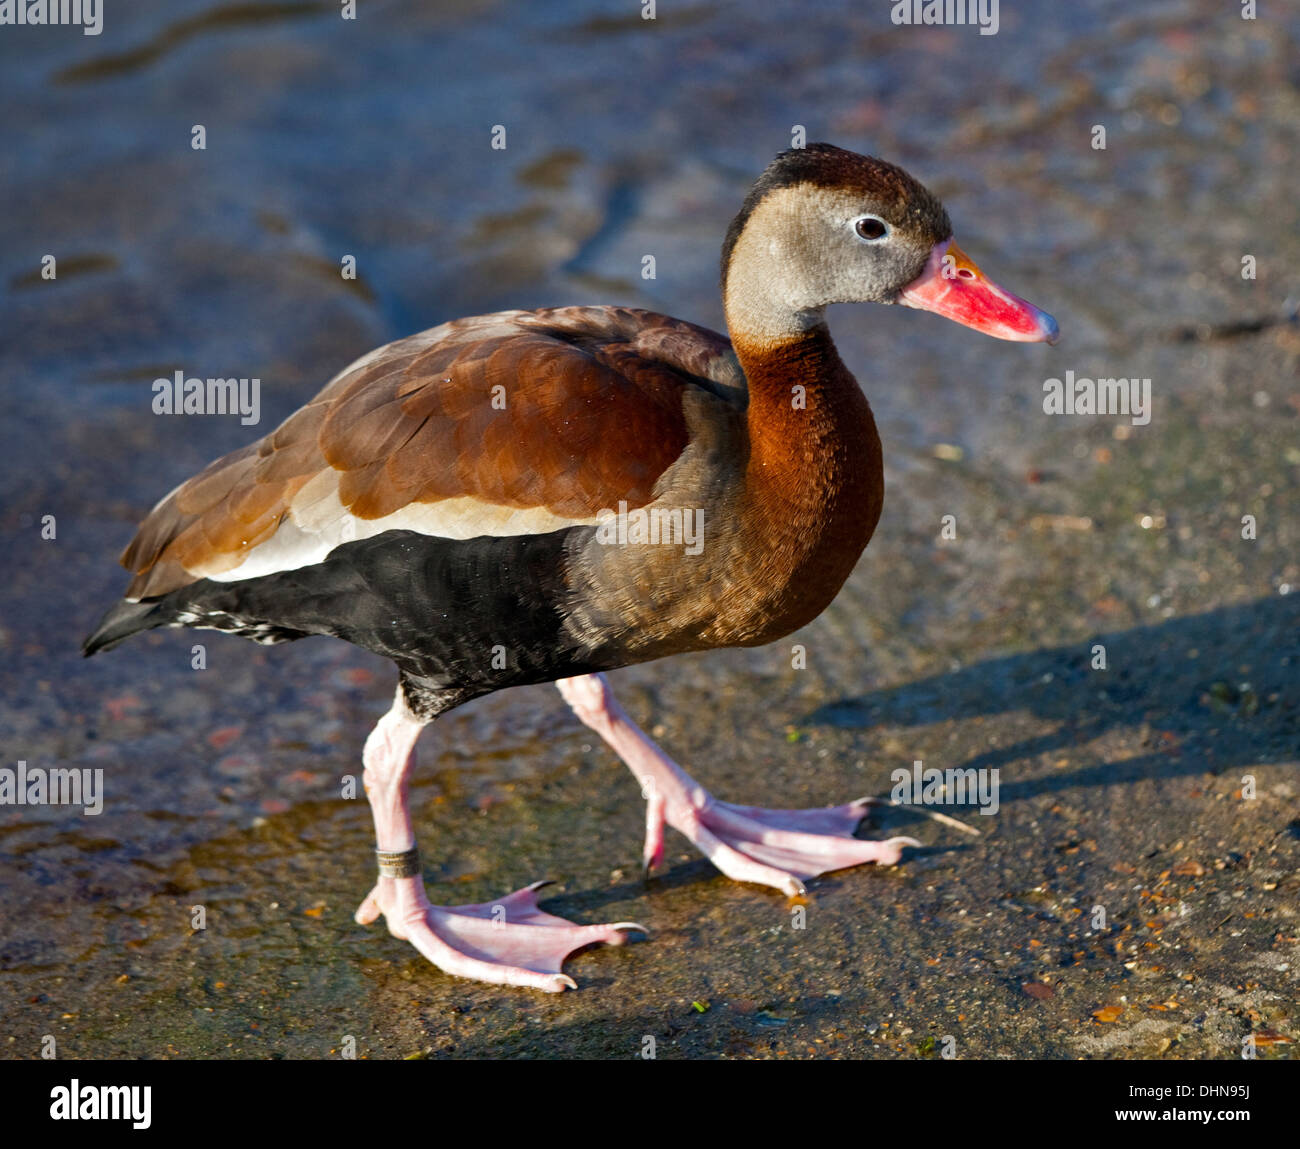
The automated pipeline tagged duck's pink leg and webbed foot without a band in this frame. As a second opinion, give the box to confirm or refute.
[555,675,920,896]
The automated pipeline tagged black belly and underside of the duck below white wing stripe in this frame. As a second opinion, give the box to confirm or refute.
[151,528,624,717]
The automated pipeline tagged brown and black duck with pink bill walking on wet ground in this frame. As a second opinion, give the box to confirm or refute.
[83,143,1058,993]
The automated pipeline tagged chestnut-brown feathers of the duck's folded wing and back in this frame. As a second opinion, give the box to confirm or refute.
[122,308,735,599]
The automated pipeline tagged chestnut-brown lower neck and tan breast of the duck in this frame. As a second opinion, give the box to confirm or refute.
[572,328,884,660]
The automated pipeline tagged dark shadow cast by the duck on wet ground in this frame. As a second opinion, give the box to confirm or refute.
[802,595,1300,805]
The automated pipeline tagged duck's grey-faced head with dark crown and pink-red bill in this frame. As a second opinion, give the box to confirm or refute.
[723,143,1058,343]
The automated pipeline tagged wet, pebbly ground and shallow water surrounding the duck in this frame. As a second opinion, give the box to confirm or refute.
[0,0,1300,1058]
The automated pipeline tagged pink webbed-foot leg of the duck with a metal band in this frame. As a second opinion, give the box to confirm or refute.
[356,689,645,993]
